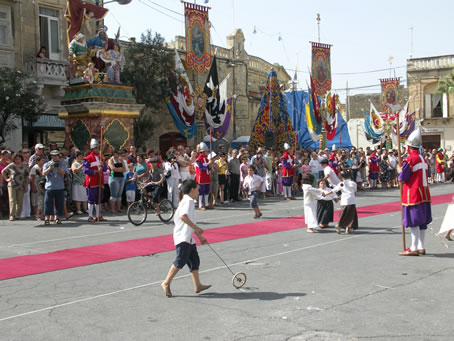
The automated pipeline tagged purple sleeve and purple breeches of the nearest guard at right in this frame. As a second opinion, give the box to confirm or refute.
[399,161,432,230]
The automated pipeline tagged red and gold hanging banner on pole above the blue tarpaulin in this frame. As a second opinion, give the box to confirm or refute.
[311,42,331,97]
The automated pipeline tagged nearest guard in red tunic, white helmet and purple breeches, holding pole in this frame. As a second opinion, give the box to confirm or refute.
[398,129,432,256]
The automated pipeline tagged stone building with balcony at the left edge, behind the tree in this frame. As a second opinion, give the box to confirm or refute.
[0,0,68,149]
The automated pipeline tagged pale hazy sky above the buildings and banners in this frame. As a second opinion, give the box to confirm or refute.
[105,0,454,99]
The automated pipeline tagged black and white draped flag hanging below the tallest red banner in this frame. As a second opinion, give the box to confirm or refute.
[203,56,232,139]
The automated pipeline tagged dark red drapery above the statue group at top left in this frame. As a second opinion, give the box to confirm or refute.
[65,0,109,44]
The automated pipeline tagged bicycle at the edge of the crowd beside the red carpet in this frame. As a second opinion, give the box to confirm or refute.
[128,189,175,226]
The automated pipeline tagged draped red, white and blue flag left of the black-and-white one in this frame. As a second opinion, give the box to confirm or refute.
[164,50,197,139]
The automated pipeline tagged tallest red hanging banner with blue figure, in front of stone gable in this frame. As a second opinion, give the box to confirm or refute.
[184,2,211,73]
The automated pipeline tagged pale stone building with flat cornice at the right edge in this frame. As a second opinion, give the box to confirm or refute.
[407,55,454,151]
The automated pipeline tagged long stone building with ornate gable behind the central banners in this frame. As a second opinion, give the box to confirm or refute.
[156,29,291,150]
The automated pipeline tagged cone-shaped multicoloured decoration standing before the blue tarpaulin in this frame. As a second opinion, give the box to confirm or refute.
[249,70,296,151]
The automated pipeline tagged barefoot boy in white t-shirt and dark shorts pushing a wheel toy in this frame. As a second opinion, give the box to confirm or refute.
[161,179,211,297]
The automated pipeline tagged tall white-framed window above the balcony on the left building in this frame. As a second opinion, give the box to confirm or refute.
[39,7,60,60]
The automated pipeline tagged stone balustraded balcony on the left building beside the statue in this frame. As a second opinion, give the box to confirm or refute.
[25,58,68,86]
